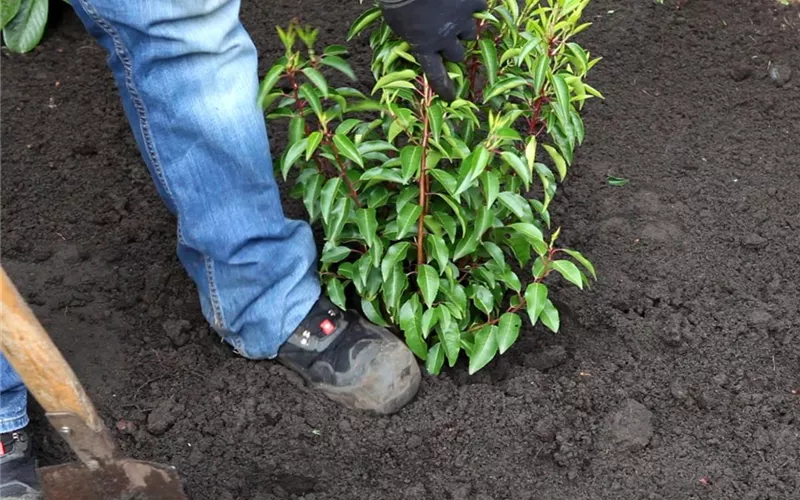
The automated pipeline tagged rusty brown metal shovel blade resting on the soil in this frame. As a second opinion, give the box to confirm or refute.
[39,458,188,500]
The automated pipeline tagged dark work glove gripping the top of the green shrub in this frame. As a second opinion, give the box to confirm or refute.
[379,0,486,101]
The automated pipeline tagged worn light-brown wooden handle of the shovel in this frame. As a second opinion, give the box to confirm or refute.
[0,266,104,433]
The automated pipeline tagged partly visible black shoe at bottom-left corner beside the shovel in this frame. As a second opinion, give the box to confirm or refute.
[0,429,44,500]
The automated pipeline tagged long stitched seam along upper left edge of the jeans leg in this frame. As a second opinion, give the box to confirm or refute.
[79,0,177,211]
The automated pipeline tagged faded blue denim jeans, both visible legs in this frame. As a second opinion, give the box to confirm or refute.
[0,0,320,432]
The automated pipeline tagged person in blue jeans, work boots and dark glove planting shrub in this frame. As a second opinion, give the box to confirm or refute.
[0,0,486,500]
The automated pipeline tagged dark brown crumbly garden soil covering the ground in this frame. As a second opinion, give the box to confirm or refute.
[0,0,800,500]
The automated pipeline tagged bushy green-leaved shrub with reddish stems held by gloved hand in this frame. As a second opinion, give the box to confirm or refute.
[259,0,601,374]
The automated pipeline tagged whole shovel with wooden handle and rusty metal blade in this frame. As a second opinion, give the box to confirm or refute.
[0,266,187,500]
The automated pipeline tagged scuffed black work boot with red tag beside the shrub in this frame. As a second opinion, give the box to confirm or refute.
[278,298,420,415]
